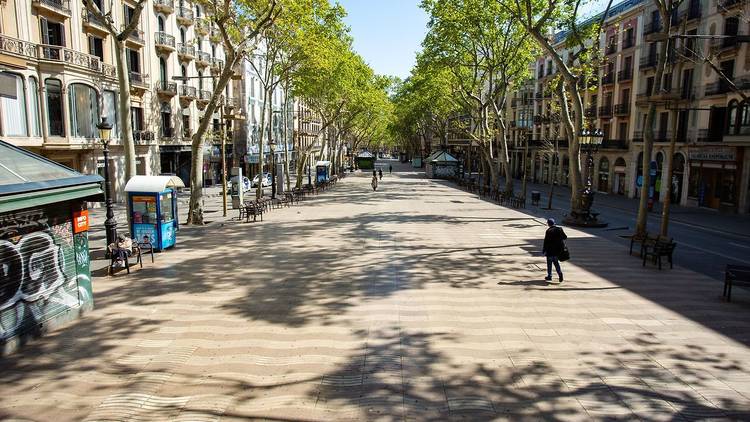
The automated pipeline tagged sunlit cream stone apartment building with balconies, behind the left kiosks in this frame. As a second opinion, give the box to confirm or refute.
[0,0,240,200]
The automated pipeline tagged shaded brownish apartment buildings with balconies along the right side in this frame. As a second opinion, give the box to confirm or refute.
[510,0,750,213]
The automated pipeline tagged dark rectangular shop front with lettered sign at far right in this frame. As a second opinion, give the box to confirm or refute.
[688,147,742,212]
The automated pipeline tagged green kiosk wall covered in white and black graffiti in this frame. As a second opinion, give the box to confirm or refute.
[0,209,89,340]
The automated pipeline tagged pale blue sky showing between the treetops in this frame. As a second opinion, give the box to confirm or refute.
[338,0,621,78]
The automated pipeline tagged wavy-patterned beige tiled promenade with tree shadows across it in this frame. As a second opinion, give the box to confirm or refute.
[0,163,750,421]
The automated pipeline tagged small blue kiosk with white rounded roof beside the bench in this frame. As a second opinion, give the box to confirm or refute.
[125,176,185,251]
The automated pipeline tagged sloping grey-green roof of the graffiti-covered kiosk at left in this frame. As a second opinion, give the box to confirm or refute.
[0,141,104,212]
